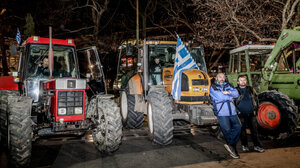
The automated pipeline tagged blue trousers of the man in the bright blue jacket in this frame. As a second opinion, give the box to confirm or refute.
[218,115,241,148]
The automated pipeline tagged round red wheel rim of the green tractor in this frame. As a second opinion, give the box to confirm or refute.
[256,102,281,129]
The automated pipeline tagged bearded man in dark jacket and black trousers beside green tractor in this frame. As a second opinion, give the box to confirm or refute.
[235,75,264,152]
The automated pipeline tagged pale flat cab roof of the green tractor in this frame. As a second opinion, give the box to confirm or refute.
[229,45,274,55]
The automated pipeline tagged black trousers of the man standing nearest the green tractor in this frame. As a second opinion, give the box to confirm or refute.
[240,116,261,147]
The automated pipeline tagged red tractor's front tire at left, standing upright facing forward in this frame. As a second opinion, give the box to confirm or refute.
[8,96,33,167]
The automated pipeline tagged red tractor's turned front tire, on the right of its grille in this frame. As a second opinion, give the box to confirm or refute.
[89,95,122,154]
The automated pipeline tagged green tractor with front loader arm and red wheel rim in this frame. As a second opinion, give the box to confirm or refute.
[227,27,300,139]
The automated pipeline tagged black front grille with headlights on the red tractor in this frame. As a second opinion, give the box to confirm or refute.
[57,91,83,115]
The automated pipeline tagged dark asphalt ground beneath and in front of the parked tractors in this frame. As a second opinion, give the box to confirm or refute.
[0,127,300,168]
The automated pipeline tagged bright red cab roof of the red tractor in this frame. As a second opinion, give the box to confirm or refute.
[22,36,75,46]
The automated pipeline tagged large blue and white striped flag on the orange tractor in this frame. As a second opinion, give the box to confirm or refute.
[172,34,199,100]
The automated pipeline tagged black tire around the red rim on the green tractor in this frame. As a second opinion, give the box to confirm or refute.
[258,90,299,139]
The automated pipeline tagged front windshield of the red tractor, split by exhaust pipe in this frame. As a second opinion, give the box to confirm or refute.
[26,44,76,79]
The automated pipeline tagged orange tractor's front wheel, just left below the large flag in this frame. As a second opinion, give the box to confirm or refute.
[147,89,174,145]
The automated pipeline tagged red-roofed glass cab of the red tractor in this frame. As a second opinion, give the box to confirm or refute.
[18,36,79,104]
